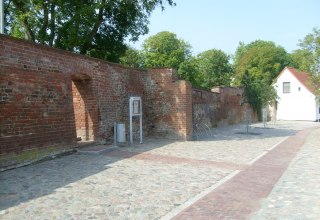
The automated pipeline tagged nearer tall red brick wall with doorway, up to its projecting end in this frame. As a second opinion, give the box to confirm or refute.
[0,35,192,168]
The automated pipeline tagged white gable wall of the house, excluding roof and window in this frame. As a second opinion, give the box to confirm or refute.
[275,69,317,121]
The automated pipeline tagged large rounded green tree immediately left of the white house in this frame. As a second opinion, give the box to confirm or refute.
[234,40,292,113]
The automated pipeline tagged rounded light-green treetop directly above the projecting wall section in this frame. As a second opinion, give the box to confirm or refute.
[143,31,191,70]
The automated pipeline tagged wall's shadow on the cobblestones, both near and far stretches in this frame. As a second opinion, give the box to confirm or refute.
[0,121,318,210]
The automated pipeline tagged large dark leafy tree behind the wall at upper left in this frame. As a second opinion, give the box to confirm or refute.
[4,0,175,61]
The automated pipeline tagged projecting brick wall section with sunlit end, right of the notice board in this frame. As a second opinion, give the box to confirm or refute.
[146,68,192,140]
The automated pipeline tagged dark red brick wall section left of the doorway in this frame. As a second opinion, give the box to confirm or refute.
[0,36,76,166]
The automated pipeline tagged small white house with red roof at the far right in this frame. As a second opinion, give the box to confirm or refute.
[274,67,320,121]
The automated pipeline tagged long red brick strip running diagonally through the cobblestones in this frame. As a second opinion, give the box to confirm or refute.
[174,126,319,220]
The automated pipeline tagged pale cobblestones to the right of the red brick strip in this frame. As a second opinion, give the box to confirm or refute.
[252,124,320,220]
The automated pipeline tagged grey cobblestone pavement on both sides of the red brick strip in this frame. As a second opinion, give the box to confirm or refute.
[0,122,320,220]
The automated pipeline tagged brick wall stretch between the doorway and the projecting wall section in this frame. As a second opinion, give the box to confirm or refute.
[95,62,148,142]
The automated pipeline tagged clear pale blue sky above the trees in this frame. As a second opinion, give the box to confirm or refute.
[130,0,320,55]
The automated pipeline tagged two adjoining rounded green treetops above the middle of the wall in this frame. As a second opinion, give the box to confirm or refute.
[142,31,233,89]
